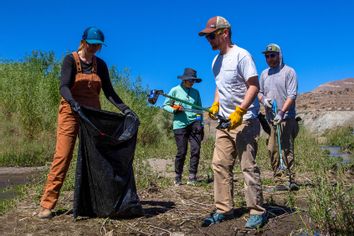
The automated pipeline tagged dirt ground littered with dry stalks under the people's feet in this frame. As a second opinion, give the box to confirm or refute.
[0,168,318,235]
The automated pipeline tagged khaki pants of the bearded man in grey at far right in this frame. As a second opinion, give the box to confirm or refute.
[267,119,299,180]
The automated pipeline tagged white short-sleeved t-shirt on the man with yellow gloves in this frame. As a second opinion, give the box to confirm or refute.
[212,45,259,120]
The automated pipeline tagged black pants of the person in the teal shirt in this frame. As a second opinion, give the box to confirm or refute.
[173,121,204,176]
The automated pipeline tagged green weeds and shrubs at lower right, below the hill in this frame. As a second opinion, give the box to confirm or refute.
[296,129,354,235]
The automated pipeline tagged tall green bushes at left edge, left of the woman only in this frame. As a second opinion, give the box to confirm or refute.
[0,52,60,166]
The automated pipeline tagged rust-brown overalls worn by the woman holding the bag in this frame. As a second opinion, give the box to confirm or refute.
[41,52,101,209]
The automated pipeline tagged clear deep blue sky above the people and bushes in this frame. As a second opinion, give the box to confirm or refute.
[0,0,354,106]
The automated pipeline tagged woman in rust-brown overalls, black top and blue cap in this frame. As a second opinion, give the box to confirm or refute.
[38,27,135,219]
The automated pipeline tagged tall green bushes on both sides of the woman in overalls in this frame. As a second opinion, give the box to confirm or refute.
[0,51,170,166]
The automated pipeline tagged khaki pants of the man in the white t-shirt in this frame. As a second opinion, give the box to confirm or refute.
[212,119,265,215]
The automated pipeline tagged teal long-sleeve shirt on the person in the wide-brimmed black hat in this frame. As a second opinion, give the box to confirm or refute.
[163,83,203,130]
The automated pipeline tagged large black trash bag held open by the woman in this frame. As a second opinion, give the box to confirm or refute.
[74,106,144,218]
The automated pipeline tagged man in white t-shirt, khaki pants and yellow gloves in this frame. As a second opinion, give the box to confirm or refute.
[199,16,267,228]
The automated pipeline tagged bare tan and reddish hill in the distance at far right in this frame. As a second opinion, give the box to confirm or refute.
[296,78,354,133]
